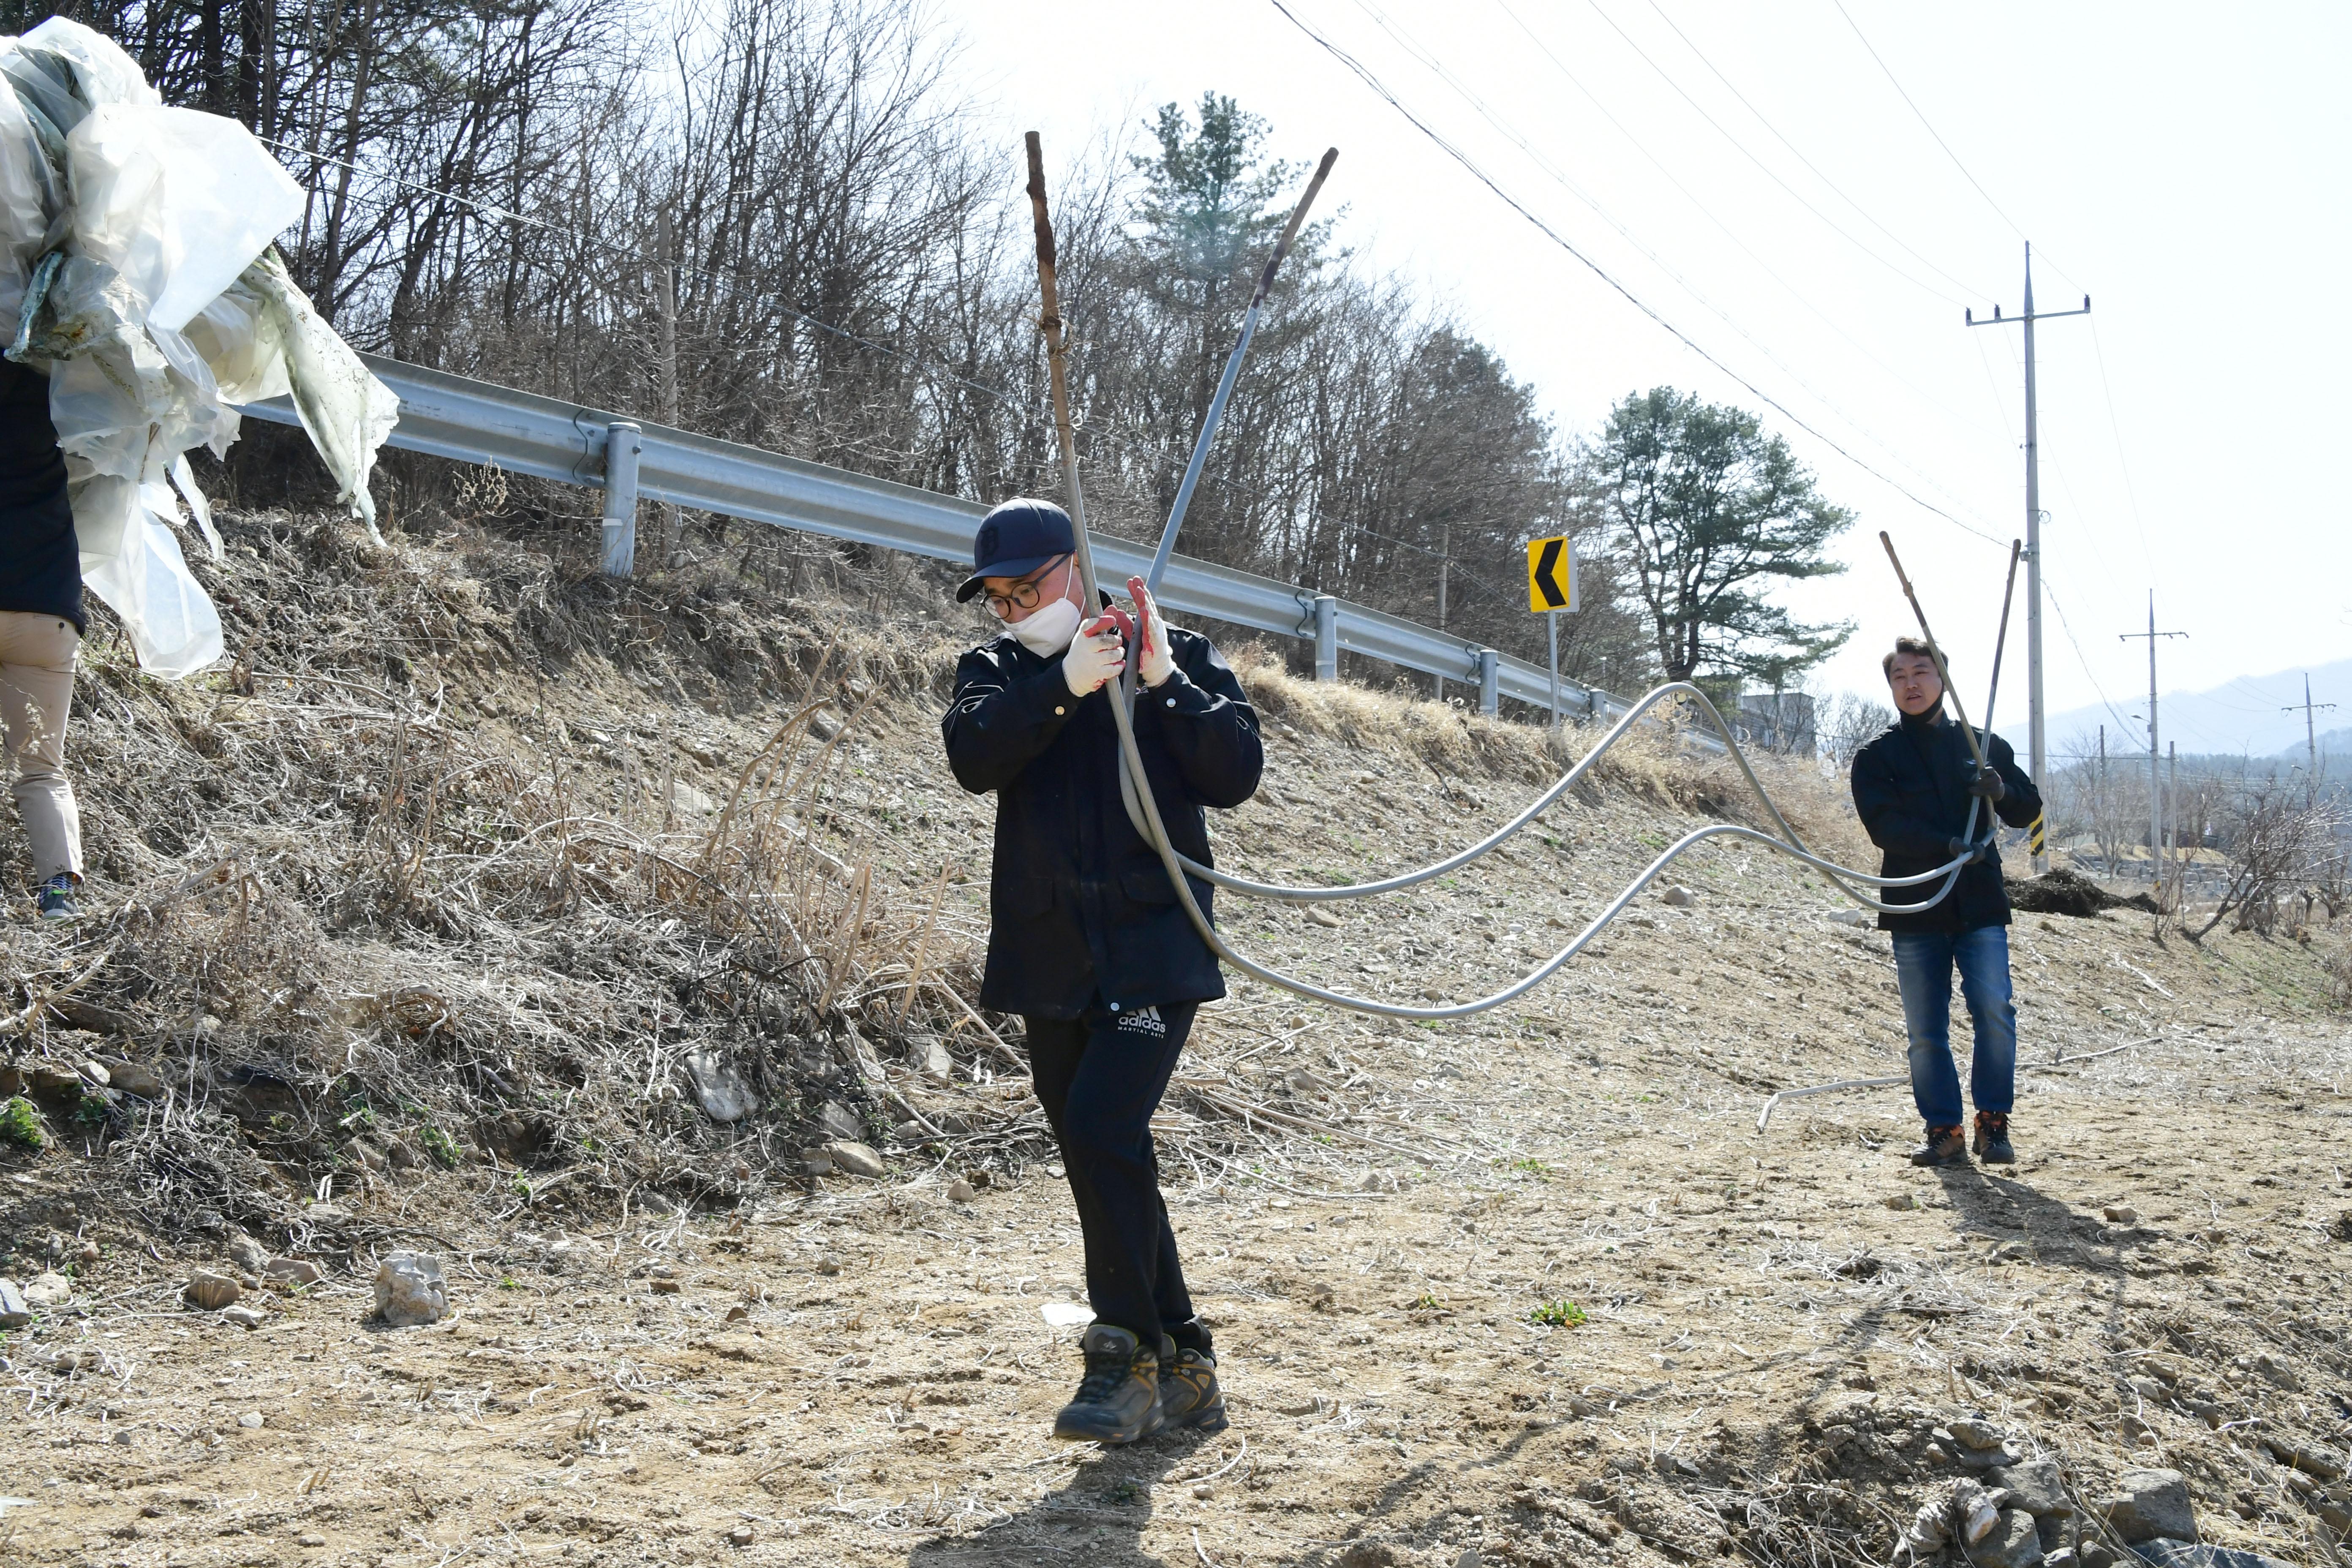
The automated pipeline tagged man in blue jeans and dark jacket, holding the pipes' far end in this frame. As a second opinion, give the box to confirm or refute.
[1854,637,2042,1166]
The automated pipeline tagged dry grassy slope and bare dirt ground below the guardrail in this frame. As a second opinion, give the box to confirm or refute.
[0,515,2352,1568]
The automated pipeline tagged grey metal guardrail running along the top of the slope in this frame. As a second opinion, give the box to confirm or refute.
[229,355,1628,722]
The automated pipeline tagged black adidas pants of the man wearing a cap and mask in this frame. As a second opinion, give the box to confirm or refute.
[1023,997,1214,1356]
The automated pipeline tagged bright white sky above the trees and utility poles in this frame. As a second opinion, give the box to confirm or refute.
[941,0,2352,750]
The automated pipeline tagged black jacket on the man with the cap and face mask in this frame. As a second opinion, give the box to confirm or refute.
[939,628,1266,1018]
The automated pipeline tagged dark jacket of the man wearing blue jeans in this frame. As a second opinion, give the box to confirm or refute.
[1854,705,2042,931]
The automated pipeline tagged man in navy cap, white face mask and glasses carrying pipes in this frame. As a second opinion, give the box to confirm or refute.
[941,501,1266,1443]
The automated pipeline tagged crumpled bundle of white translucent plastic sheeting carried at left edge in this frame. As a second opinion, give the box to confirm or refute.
[0,16,400,679]
